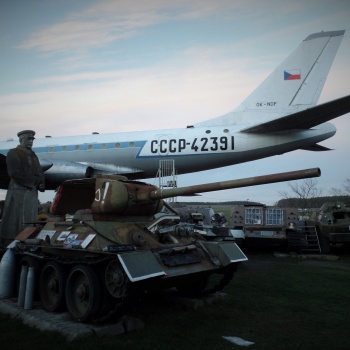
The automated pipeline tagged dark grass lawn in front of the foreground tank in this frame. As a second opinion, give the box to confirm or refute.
[0,252,350,350]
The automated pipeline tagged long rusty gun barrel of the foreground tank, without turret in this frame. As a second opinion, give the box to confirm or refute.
[150,168,321,200]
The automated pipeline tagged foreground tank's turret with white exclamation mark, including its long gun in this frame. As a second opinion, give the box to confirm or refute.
[52,168,321,216]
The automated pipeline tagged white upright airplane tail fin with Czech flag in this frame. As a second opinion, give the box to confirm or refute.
[196,30,345,125]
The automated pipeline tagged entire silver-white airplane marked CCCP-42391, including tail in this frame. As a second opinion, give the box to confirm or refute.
[0,30,350,190]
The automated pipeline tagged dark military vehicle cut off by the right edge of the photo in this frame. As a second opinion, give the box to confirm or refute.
[304,202,350,254]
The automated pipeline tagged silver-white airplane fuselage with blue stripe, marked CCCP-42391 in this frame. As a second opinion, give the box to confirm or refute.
[0,123,335,188]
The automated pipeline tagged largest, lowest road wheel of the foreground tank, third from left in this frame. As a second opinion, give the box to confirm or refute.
[66,265,101,322]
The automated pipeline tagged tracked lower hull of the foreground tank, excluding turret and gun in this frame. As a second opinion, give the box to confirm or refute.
[9,215,247,322]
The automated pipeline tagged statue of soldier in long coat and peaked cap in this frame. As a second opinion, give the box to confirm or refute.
[0,130,45,244]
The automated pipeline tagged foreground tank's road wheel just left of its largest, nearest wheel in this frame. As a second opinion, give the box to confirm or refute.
[39,261,67,312]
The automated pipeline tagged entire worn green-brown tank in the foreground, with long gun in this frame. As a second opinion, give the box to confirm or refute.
[4,168,320,322]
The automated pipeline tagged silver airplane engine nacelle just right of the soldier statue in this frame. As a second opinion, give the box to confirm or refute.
[40,160,94,190]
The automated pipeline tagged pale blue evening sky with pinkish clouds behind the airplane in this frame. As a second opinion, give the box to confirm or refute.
[0,0,350,205]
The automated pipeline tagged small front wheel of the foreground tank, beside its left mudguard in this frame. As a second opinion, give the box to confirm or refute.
[105,260,128,298]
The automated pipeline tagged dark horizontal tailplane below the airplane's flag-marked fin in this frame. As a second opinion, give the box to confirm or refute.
[241,95,350,134]
